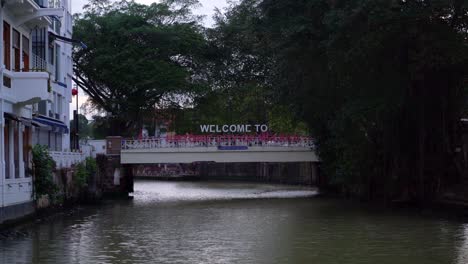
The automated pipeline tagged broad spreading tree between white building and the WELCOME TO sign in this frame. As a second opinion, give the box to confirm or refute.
[73,0,205,136]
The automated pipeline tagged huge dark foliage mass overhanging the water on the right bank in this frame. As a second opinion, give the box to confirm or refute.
[215,0,468,203]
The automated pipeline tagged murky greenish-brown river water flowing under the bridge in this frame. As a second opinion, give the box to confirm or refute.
[0,181,468,264]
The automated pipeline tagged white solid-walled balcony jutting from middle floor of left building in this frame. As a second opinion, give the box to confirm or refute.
[4,71,50,105]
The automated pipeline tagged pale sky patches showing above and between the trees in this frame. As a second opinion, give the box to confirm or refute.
[70,0,228,119]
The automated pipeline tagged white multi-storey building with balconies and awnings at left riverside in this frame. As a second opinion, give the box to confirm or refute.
[0,0,72,223]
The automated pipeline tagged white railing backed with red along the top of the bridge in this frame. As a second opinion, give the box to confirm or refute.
[122,135,314,150]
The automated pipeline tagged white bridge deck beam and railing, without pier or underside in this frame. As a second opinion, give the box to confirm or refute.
[120,135,319,164]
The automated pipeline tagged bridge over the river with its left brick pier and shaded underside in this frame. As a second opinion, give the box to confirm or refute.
[97,135,322,195]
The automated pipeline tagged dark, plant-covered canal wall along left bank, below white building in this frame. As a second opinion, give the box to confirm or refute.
[0,155,133,229]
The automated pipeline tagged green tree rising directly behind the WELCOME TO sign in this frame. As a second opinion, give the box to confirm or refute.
[178,1,306,133]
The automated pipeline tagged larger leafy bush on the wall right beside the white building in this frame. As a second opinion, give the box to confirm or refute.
[32,145,59,199]
